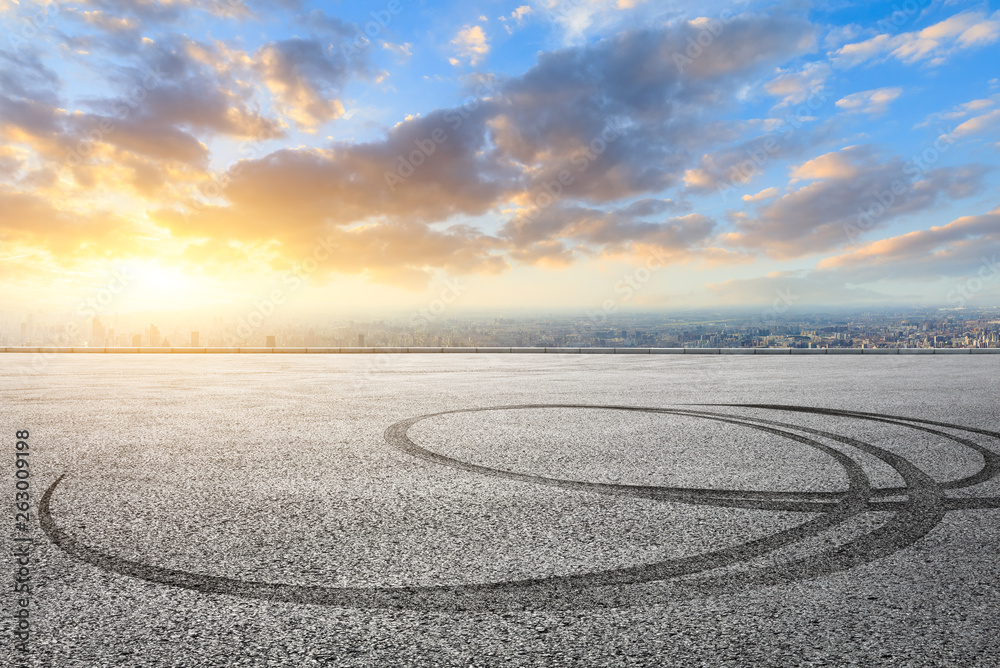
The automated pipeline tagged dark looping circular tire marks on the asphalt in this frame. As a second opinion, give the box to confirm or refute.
[39,404,1000,611]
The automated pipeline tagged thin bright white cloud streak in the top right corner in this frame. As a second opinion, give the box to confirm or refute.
[830,11,1000,67]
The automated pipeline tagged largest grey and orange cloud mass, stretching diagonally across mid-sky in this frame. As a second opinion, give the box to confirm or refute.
[139,15,813,280]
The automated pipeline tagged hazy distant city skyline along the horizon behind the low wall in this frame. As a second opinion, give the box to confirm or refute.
[0,308,1000,348]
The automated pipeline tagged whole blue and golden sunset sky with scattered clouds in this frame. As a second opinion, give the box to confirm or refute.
[0,0,1000,314]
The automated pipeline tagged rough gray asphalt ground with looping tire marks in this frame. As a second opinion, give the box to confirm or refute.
[0,354,1000,667]
